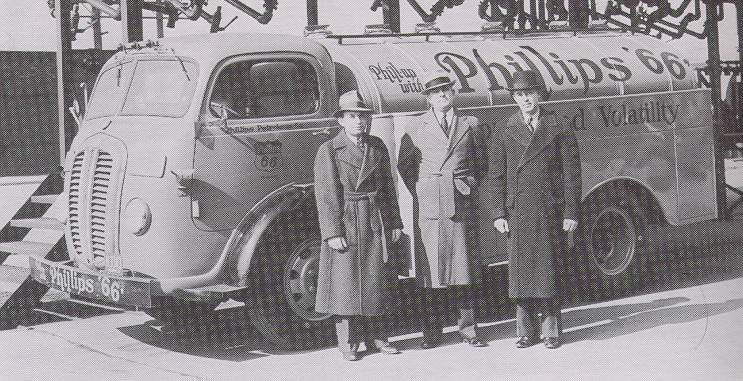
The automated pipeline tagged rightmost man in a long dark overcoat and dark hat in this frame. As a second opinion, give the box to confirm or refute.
[490,70,581,349]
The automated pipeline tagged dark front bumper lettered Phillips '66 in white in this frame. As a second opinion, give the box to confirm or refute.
[31,257,152,307]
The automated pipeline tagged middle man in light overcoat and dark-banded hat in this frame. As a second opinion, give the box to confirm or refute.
[397,71,486,349]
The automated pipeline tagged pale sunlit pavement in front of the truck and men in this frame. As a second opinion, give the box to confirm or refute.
[0,257,743,380]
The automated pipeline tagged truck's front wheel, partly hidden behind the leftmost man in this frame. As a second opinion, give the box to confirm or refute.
[246,206,335,350]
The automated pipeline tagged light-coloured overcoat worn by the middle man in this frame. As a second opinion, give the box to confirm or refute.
[397,110,480,288]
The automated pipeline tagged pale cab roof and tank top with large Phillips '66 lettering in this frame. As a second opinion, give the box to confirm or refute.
[101,32,699,113]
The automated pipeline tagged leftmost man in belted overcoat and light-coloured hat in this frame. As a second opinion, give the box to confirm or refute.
[314,90,402,361]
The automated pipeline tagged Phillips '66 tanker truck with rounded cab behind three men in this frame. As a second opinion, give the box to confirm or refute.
[31,26,718,348]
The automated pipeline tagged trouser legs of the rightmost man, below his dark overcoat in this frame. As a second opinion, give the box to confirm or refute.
[516,298,562,338]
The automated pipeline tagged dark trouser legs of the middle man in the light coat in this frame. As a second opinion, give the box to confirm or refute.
[420,286,477,343]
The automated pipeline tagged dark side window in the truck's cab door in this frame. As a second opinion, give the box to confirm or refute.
[209,59,320,119]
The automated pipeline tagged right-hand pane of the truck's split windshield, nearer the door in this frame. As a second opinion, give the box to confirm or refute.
[121,59,197,117]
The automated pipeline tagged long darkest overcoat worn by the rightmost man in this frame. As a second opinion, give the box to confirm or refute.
[490,109,581,298]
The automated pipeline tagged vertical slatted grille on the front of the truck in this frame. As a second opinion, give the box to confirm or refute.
[68,149,115,268]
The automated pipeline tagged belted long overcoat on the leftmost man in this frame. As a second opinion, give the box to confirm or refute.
[314,130,402,316]
